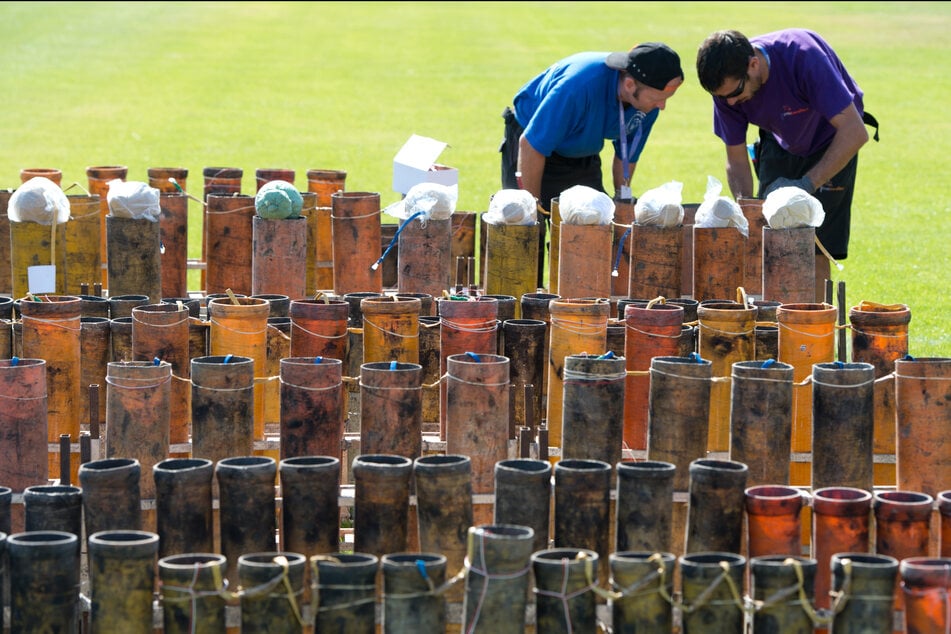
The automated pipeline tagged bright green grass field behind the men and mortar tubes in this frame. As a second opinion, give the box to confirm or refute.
[0,2,951,357]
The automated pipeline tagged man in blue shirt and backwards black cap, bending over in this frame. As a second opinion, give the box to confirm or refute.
[499,42,684,286]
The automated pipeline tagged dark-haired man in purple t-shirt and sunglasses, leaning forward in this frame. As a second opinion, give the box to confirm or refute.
[697,29,878,301]
